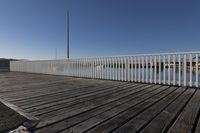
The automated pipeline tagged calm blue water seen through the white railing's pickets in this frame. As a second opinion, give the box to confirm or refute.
[52,66,200,85]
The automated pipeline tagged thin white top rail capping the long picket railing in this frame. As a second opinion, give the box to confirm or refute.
[11,51,200,62]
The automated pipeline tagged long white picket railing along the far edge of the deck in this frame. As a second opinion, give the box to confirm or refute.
[10,52,200,87]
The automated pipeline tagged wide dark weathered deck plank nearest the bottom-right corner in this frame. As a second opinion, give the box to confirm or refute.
[168,89,200,133]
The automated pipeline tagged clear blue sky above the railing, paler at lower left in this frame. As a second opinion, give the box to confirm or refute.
[0,0,200,59]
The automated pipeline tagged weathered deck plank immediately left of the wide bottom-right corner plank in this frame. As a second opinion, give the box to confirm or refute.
[140,89,195,133]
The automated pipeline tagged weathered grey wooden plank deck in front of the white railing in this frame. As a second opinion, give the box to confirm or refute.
[0,72,200,133]
